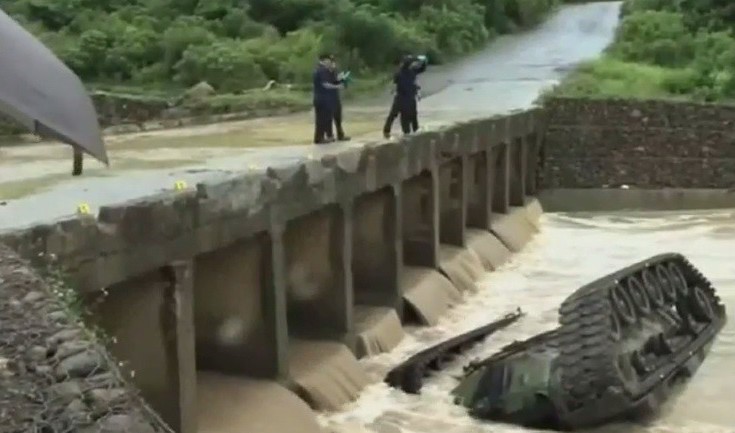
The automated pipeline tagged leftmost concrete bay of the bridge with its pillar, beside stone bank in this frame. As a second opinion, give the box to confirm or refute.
[84,263,188,433]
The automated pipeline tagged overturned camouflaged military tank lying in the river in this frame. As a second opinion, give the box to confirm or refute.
[452,254,726,430]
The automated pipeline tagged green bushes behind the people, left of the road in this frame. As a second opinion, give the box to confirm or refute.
[2,0,557,107]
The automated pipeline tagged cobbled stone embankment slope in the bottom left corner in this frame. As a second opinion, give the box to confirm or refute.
[0,245,167,433]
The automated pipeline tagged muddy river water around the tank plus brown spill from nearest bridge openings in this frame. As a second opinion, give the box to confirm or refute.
[194,210,735,433]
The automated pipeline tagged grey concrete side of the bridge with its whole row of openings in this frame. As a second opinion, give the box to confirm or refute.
[3,110,544,432]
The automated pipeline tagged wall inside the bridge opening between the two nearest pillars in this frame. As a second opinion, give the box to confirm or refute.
[194,233,277,377]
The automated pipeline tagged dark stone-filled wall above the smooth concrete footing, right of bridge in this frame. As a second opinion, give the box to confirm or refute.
[542,98,735,189]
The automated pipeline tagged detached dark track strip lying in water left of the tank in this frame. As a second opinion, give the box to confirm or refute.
[385,308,525,394]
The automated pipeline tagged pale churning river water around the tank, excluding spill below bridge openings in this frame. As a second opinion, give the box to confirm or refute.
[321,210,735,433]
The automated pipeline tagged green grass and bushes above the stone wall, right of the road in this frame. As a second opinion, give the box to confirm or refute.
[553,0,735,101]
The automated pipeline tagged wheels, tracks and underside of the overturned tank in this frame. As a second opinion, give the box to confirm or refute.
[551,253,726,429]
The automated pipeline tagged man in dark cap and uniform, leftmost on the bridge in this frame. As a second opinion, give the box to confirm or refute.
[313,54,342,144]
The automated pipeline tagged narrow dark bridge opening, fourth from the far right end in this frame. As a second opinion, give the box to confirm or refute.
[467,150,495,230]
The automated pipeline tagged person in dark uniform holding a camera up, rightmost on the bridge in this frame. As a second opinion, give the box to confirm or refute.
[383,56,427,138]
